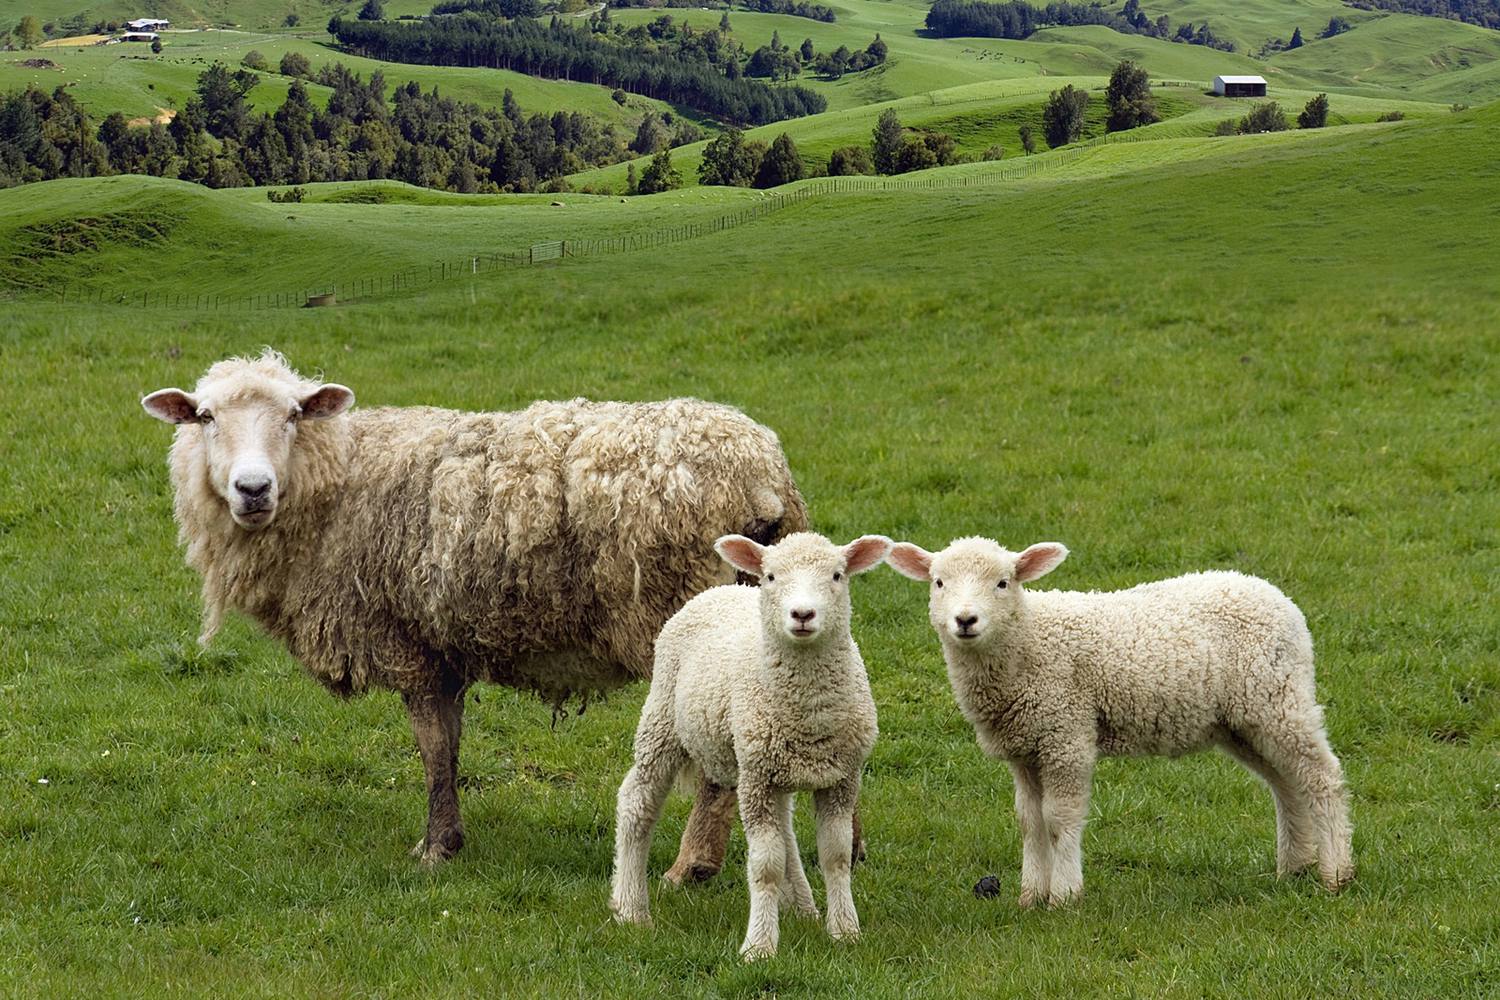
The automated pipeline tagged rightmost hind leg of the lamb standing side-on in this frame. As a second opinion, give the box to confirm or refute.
[1253,712,1355,892]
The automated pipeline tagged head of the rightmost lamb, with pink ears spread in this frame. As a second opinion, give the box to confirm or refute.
[887,538,1068,646]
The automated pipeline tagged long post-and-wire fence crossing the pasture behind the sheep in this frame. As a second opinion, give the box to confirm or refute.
[38,136,1107,312]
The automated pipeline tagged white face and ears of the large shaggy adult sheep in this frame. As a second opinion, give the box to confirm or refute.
[141,351,354,531]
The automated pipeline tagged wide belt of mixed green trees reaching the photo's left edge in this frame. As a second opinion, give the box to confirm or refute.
[0,61,654,192]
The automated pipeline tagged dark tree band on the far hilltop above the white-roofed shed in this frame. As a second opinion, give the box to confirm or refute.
[927,0,1235,52]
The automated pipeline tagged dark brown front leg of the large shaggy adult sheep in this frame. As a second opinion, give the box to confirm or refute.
[402,676,467,868]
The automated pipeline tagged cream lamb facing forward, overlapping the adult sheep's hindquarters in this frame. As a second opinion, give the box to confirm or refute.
[609,532,891,961]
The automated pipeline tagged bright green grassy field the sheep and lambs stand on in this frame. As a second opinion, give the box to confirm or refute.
[0,99,1500,999]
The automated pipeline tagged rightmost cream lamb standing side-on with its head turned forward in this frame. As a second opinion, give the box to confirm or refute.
[890,538,1355,907]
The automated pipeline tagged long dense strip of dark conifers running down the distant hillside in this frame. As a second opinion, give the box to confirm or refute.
[329,13,828,124]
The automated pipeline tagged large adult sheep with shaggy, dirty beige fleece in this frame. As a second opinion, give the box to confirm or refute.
[141,349,807,882]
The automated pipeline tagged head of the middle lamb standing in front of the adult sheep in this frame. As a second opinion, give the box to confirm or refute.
[714,532,891,645]
